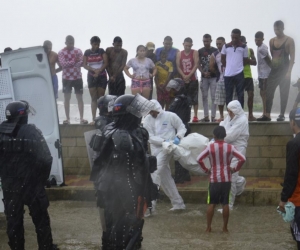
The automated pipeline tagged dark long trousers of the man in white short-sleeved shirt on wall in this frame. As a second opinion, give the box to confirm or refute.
[224,71,244,108]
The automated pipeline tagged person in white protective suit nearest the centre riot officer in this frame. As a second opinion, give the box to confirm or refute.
[143,100,186,213]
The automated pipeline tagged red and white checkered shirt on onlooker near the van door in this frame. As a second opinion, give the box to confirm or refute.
[58,48,83,80]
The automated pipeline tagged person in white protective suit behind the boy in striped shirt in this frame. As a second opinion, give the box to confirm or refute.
[220,100,249,209]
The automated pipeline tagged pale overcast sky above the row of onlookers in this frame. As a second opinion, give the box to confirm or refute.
[0,0,300,88]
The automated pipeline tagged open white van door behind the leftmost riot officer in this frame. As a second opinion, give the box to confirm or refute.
[1,46,64,185]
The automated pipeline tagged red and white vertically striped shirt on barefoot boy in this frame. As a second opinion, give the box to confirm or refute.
[197,141,246,182]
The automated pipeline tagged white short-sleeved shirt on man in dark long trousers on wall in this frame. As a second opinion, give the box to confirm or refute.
[221,43,248,76]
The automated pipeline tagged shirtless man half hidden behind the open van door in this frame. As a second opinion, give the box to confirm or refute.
[43,40,62,99]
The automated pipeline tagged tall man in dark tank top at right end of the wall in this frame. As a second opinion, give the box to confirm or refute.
[257,21,295,121]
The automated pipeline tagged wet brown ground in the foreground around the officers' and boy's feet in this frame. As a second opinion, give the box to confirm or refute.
[0,201,296,250]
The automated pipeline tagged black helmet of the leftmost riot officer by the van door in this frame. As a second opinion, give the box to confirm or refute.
[5,101,29,121]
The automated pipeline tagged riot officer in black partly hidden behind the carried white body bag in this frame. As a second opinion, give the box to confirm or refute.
[169,78,192,183]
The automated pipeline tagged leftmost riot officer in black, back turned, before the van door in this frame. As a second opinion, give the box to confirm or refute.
[0,101,58,250]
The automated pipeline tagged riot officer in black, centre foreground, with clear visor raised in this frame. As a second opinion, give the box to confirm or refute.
[90,94,157,250]
